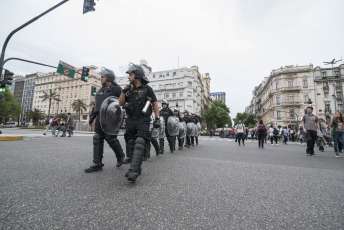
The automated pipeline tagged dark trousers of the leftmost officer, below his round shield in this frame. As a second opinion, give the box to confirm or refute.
[93,118,124,164]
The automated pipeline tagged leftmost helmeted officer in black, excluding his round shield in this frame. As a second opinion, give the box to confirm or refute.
[85,67,124,173]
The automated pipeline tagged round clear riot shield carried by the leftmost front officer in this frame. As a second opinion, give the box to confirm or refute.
[99,97,124,135]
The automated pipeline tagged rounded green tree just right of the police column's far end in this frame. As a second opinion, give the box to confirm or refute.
[202,100,232,129]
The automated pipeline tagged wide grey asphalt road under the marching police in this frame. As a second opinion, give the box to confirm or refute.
[0,130,344,229]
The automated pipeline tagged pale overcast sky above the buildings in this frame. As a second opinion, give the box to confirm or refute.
[0,0,344,118]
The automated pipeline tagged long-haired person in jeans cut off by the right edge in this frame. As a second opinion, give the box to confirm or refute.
[329,111,344,157]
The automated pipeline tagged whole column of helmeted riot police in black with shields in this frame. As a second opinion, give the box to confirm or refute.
[85,63,198,182]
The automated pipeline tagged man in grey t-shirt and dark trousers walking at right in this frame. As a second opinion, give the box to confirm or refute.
[302,106,320,156]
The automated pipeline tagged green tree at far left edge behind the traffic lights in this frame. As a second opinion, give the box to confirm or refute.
[0,86,22,121]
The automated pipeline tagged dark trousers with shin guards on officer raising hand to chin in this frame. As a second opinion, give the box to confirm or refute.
[124,116,151,174]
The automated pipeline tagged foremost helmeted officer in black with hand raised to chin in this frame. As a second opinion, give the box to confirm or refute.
[119,64,160,182]
